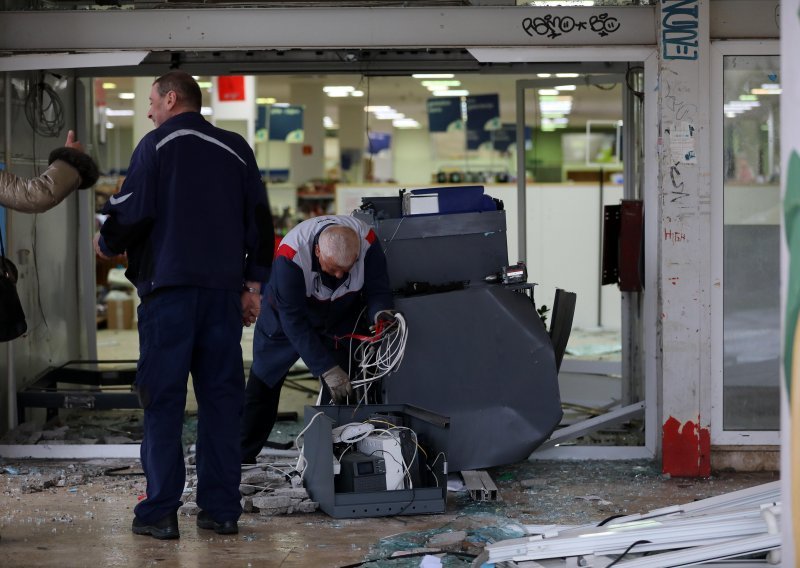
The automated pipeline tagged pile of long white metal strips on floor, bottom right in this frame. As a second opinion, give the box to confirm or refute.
[484,482,781,568]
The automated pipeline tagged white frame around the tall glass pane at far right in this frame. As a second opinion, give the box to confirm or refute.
[709,40,780,446]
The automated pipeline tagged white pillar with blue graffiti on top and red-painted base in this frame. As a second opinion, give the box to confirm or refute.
[657,0,722,477]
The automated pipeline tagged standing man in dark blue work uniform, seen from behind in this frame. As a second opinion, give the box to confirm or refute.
[95,71,274,539]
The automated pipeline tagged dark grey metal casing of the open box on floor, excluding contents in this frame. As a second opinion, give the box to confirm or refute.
[303,404,450,519]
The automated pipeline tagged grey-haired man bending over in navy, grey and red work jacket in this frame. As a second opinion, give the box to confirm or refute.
[241,215,394,463]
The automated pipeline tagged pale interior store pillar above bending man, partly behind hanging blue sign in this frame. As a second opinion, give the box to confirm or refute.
[289,81,326,185]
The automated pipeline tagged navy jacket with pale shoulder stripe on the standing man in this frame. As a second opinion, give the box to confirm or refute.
[99,112,274,297]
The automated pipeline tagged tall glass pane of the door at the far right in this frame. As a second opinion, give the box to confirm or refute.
[722,56,780,430]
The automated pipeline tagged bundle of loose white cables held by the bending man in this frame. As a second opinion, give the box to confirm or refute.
[352,313,408,387]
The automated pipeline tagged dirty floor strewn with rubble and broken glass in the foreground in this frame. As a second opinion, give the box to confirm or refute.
[0,459,778,567]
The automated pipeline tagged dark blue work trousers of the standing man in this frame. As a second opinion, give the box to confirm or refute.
[135,287,244,522]
